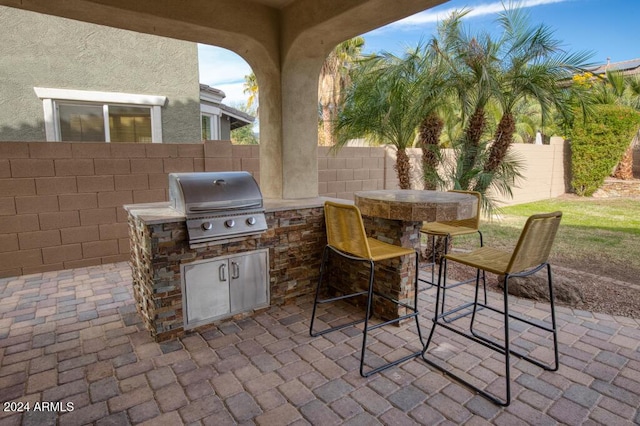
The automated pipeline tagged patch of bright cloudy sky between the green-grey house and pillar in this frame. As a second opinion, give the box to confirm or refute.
[198,44,252,105]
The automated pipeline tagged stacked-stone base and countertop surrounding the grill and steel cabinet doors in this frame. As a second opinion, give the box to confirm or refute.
[124,198,336,341]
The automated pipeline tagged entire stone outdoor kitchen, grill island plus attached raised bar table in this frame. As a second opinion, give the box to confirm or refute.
[125,172,475,341]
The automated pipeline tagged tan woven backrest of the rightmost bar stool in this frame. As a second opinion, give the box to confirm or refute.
[506,212,562,273]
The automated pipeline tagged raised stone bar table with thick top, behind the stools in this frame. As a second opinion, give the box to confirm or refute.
[355,190,477,319]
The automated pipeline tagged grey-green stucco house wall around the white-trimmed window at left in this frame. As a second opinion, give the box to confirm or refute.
[0,6,200,143]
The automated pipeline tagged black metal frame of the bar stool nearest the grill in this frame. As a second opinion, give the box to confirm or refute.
[309,201,424,377]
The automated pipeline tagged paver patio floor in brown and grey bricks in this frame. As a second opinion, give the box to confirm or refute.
[0,263,640,425]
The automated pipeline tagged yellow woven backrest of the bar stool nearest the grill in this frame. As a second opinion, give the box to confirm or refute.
[324,201,371,259]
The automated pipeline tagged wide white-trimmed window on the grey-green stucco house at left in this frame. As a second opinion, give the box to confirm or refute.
[34,87,166,143]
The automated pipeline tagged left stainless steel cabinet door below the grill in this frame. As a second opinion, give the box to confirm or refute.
[183,259,231,327]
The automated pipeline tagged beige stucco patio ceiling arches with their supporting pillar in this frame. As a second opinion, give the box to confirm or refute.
[0,0,445,199]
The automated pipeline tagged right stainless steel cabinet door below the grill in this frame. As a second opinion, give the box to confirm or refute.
[229,250,269,313]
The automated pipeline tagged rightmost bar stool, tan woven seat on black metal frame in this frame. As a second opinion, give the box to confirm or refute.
[422,212,562,407]
